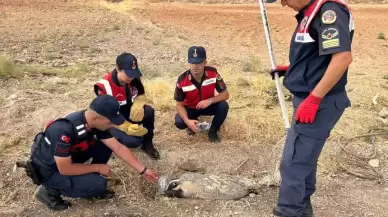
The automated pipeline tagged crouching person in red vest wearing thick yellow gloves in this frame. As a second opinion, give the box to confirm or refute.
[94,53,160,159]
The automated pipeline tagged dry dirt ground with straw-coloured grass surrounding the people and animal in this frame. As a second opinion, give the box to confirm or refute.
[0,0,388,217]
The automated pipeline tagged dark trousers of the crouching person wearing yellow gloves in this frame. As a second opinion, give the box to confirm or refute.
[110,105,155,148]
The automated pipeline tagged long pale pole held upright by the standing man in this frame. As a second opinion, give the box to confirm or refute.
[258,0,290,131]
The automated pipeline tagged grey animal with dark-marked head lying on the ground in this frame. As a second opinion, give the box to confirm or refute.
[158,172,262,200]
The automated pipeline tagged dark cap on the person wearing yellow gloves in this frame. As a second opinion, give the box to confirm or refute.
[116,53,142,78]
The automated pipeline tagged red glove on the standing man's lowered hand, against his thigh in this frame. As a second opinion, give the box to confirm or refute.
[295,93,322,124]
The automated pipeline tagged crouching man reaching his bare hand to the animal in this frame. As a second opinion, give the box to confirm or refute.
[27,95,158,210]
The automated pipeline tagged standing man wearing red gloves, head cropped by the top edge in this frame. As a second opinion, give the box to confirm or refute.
[267,0,354,217]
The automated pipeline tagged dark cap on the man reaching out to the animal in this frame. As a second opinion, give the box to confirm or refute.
[89,95,125,125]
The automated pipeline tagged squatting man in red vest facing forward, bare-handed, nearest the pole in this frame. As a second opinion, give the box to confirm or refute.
[174,46,229,142]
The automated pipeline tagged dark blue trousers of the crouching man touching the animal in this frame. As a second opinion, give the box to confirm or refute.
[42,141,112,198]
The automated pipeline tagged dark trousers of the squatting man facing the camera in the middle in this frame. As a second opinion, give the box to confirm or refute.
[175,101,229,131]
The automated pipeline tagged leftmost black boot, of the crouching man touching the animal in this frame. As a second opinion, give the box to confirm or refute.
[35,185,71,210]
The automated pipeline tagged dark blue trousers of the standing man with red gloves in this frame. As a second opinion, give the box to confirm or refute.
[278,92,350,217]
